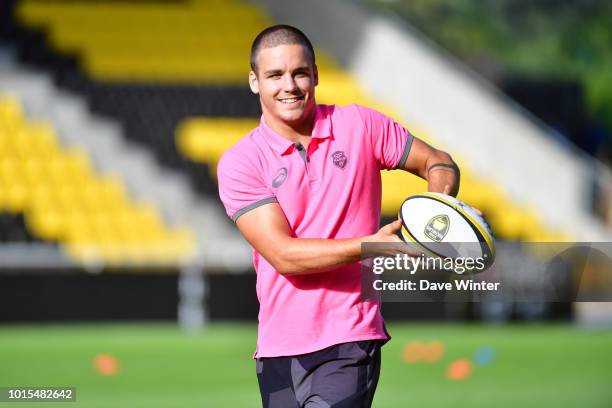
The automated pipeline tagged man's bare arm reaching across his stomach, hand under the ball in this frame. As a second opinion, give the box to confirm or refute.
[236,203,402,275]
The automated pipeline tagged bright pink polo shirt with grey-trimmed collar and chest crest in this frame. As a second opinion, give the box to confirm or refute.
[217,105,413,357]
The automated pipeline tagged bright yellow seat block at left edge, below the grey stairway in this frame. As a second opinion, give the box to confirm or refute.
[0,95,194,265]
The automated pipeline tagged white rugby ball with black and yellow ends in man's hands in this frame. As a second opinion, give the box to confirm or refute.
[399,193,495,267]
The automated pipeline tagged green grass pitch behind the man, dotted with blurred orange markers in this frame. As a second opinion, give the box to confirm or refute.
[0,323,612,408]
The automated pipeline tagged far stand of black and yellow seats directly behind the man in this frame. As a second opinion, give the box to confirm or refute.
[3,0,567,240]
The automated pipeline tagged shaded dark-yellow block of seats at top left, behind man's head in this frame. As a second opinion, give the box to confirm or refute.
[17,1,270,84]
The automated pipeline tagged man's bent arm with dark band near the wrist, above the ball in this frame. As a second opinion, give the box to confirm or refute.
[403,137,460,196]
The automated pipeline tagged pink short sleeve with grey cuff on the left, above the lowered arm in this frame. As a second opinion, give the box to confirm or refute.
[217,152,276,222]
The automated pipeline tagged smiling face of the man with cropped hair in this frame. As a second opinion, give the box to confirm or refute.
[249,44,318,126]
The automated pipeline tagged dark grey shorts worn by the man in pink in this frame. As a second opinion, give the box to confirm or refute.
[257,340,383,408]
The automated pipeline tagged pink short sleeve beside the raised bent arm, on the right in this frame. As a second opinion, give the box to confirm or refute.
[357,105,414,170]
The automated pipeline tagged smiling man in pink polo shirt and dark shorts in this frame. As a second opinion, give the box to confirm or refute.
[218,25,459,408]
